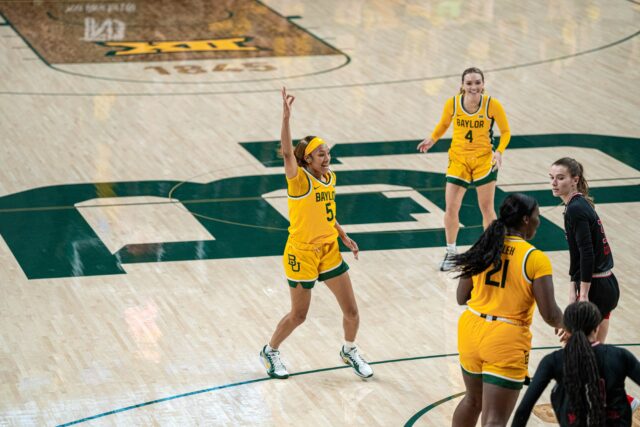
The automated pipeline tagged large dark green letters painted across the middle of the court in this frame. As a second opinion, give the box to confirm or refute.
[0,135,640,280]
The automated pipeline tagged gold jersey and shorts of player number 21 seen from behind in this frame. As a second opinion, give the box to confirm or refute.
[458,236,552,390]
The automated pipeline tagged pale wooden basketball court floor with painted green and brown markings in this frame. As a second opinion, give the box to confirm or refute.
[0,0,640,426]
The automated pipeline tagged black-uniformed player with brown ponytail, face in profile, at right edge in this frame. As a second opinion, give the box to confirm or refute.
[549,157,620,342]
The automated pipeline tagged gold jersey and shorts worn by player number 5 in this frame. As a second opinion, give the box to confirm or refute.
[282,167,349,289]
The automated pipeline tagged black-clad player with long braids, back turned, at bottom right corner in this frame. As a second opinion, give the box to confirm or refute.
[512,302,640,427]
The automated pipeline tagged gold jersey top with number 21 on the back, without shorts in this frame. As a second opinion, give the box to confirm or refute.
[468,236,552,325]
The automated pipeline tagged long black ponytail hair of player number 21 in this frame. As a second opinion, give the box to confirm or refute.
[453,193,538,278]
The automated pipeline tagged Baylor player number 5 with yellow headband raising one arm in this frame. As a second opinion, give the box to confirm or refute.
[260,88,373,378]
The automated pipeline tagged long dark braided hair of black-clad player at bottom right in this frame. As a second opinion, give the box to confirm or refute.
[563,301,605,427]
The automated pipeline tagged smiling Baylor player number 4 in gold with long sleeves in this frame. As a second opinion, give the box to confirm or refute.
[418,68,511,271]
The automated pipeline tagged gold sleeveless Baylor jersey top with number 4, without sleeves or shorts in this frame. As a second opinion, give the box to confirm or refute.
[451,95,493,155]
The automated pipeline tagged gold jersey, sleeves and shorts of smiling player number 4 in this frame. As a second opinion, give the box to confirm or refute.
[431,95,511,188]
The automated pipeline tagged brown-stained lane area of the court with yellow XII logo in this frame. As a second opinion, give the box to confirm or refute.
[0,0,341,65]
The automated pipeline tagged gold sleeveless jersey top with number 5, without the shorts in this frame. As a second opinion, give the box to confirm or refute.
[287,167,338,244]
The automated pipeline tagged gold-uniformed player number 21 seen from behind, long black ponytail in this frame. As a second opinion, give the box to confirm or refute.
[453,193,562,426]
